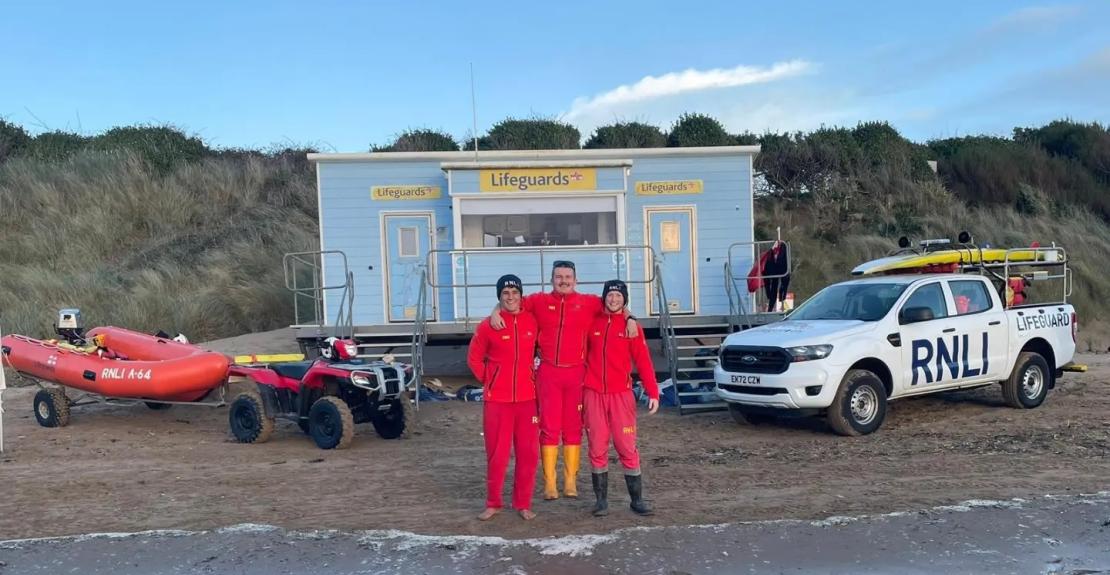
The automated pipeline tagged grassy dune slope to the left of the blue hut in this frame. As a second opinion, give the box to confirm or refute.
[0,151,316,341]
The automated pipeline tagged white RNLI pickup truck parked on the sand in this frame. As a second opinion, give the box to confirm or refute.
[714,273,1077,435]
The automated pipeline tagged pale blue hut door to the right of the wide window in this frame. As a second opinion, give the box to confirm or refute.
[644,205,697,315]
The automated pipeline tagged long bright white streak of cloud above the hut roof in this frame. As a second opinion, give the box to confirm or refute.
[564,60,813,121]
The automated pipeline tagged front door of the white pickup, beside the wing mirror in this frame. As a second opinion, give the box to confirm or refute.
[898,281,955,393]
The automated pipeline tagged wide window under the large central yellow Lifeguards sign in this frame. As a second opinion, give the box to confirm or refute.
[461,196,618,248]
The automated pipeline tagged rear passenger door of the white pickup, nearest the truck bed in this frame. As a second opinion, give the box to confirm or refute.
[948,279,1008,382]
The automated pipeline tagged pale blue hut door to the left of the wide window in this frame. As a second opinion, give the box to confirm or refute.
[382,212,436,323]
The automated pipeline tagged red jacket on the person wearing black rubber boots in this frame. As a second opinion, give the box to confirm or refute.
[586,311,659,400]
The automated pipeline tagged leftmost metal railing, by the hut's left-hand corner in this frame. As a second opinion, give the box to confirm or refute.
[282,250,354,337]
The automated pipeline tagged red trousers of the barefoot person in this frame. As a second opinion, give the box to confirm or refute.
[482,400,539,510]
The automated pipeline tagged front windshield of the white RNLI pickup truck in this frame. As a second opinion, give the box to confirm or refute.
[786,283,908,322]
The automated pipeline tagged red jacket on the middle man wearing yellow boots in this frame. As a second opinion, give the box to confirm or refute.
[523,291,602,367]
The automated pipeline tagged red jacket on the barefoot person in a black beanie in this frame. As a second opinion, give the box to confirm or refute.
[466,311,539,403]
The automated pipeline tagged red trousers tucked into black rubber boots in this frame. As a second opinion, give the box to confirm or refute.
[584,389,639,475]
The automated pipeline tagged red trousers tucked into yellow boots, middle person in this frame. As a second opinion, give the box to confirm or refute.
[536,363,586,445]
